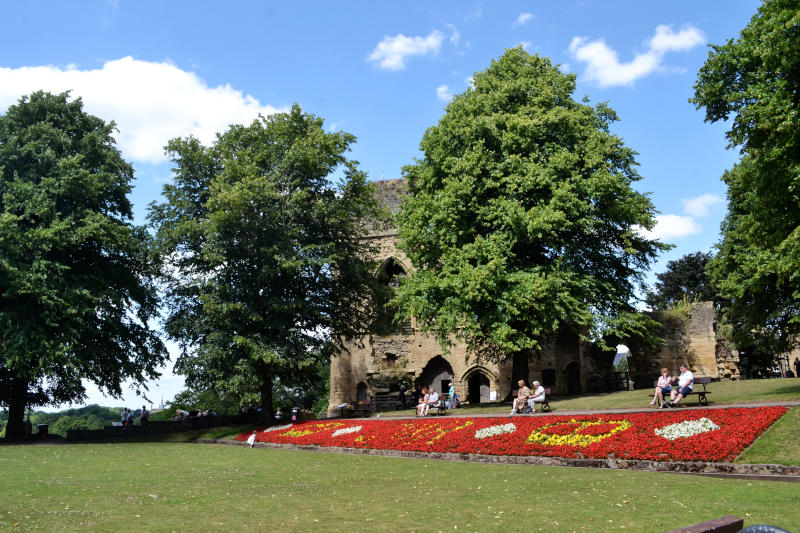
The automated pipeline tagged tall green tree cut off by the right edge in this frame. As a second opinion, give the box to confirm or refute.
[692,0,800,353]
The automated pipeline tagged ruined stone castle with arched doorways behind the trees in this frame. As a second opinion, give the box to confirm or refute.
[328,179,739,413]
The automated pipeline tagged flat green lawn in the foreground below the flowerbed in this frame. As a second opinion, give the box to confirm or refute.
[0,443,800,531]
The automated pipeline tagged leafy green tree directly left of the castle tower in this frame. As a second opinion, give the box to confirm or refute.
[150,106,376,416]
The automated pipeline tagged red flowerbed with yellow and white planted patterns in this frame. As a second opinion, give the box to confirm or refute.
[236,407,787,461]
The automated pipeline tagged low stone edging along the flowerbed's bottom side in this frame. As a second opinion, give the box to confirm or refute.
[195,439,800,482]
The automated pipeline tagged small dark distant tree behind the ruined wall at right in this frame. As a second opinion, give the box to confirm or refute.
[645,252,717,309]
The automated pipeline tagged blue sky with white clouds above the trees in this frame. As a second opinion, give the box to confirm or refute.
[0,0,760,406]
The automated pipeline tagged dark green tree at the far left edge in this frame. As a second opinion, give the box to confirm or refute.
[0,92,166,438]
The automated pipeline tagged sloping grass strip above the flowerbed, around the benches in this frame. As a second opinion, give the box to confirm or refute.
[382,378,800,416]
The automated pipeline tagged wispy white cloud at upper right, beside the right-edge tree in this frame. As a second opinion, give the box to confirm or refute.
[569,24,705,87]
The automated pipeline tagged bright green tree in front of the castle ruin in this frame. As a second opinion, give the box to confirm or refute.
[396,48,664,373]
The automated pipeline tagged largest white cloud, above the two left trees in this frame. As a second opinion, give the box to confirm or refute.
[0,56,279,163]
